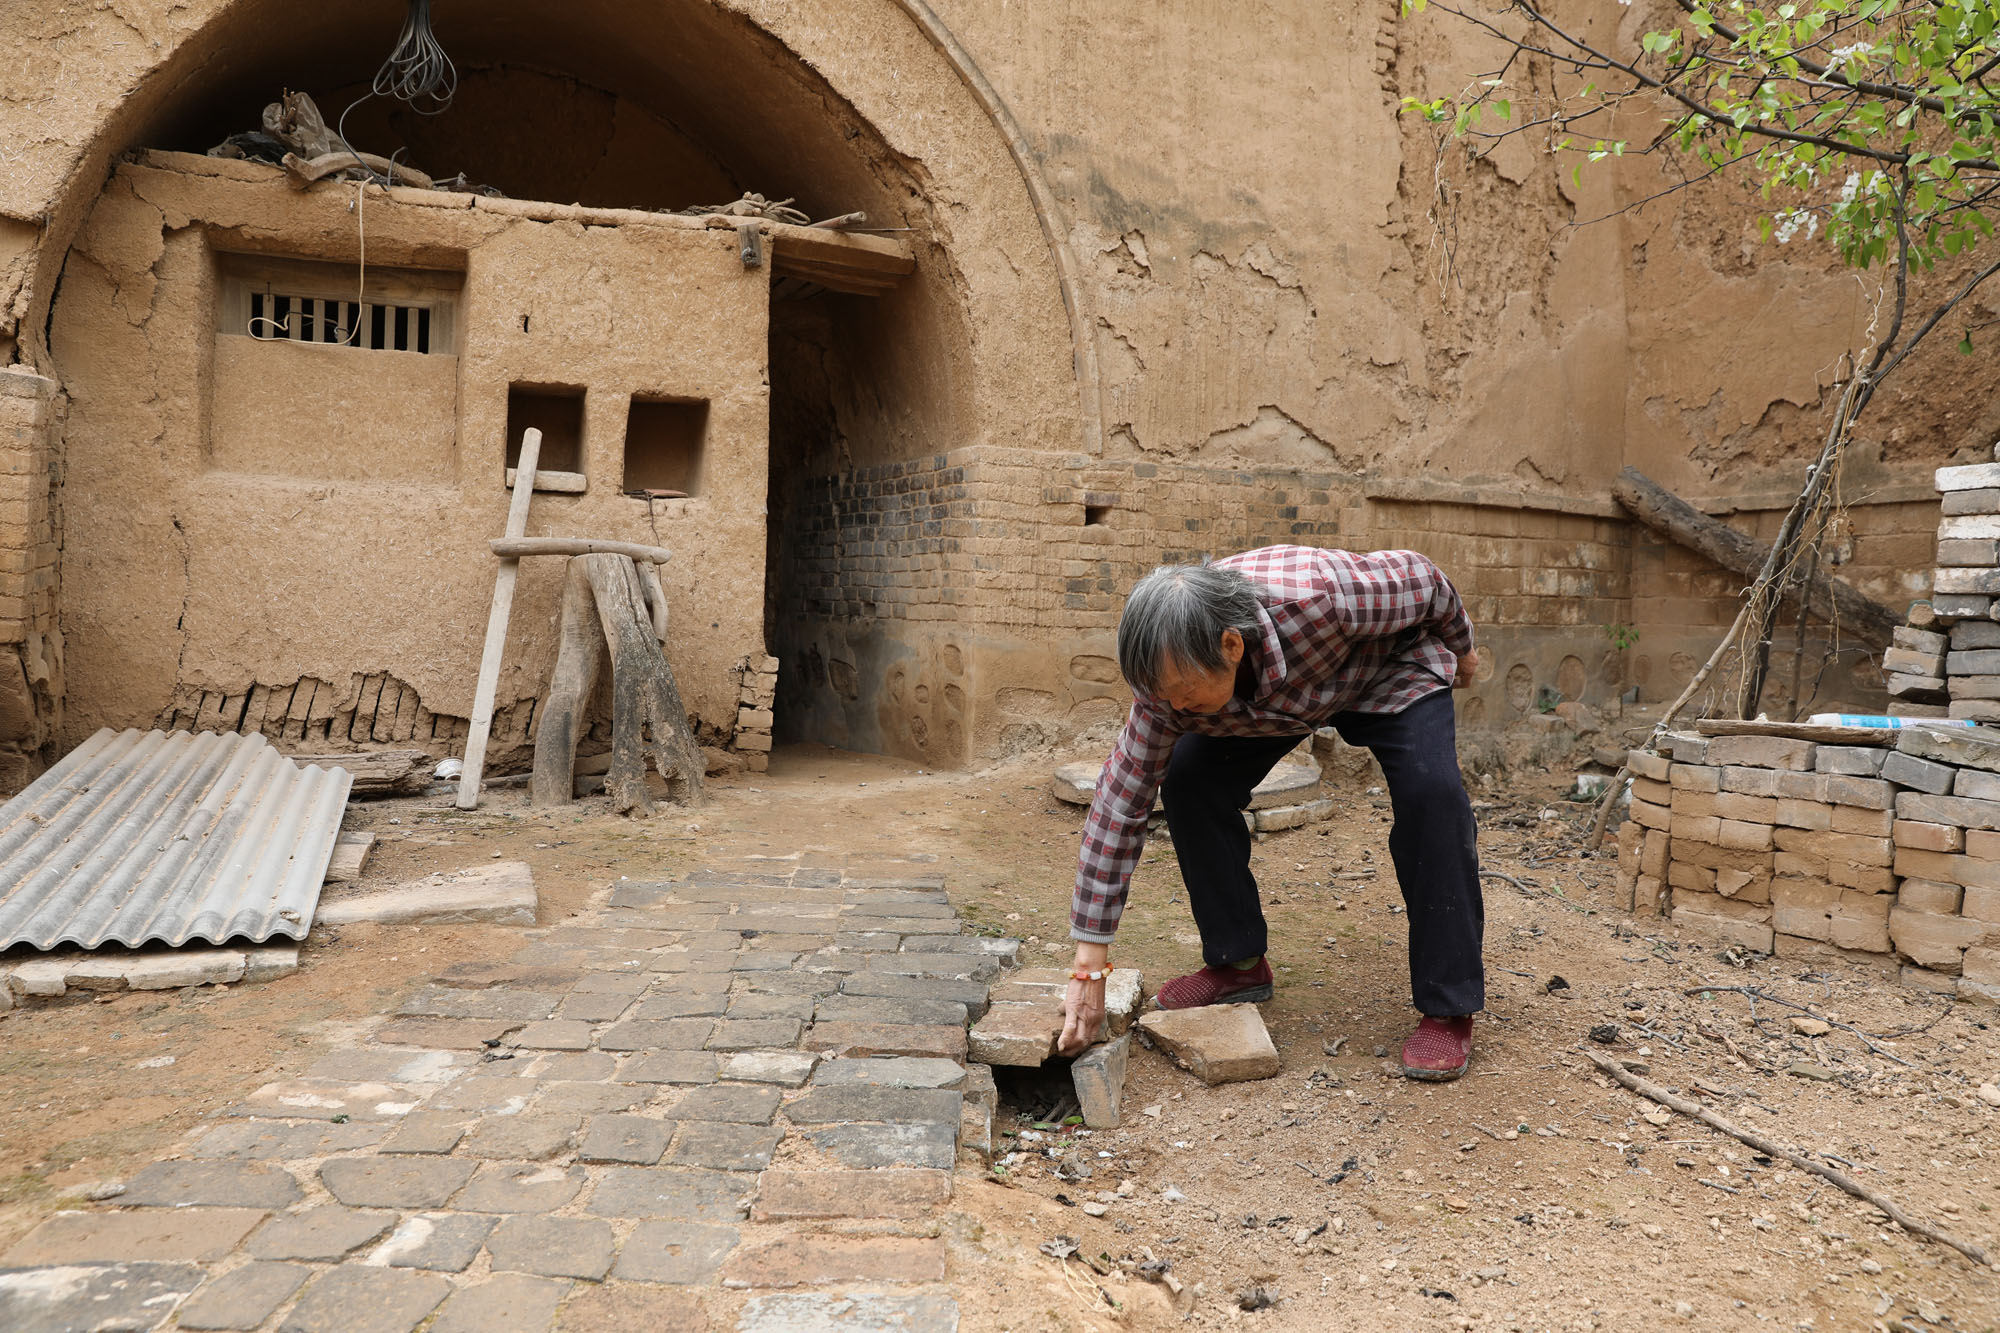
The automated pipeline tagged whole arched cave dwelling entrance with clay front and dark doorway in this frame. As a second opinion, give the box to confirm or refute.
[35,0,1074,765]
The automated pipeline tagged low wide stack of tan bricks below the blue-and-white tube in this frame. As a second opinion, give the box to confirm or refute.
[1620,729,2000,1003]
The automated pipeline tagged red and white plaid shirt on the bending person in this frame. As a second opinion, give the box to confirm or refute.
[1070,546,1472,943]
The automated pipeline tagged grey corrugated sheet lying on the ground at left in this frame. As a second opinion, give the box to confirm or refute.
[0,729,354,949]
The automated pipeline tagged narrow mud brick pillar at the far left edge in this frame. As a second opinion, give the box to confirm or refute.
[0,366,64,791]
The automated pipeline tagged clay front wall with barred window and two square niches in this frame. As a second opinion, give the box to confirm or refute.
[52,158,768,747]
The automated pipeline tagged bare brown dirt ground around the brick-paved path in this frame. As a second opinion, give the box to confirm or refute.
[0,749,2000,1331]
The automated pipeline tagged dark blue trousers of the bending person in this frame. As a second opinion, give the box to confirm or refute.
[1160,691,1486,1019]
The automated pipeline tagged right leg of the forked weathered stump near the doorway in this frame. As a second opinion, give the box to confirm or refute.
[578,554,704,815]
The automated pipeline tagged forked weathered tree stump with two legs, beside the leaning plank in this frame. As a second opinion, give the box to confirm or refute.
[530,554,702,815]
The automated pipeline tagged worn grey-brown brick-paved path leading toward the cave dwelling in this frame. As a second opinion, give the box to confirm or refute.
[0,859,1018,1333]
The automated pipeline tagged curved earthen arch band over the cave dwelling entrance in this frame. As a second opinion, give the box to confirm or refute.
[0,0,1098,450]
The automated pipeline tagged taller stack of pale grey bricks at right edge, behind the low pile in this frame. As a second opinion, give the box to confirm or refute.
[1882,462,2000,723]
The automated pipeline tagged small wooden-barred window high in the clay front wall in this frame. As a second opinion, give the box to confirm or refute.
[216,254,460,354]
